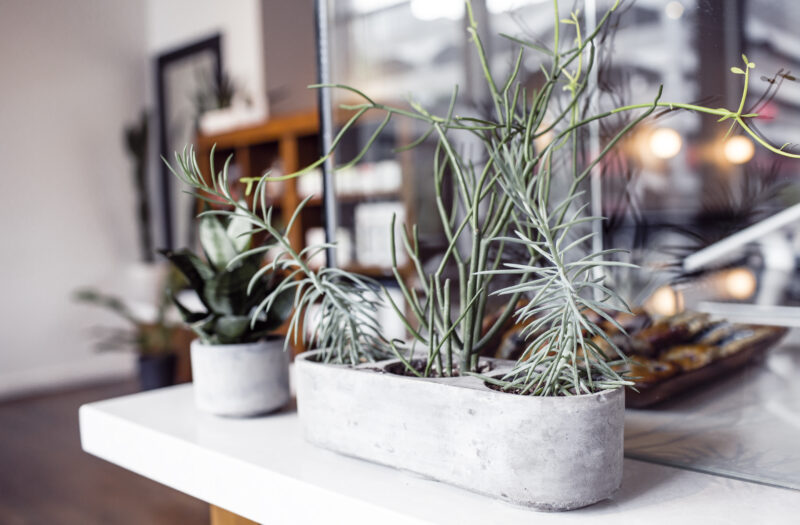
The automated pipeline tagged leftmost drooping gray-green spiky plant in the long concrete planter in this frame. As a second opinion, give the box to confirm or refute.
[170,148,389,364]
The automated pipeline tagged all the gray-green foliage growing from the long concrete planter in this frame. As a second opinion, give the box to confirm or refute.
[166,0,795,395]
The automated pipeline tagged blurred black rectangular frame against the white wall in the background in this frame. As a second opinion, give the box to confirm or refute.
[155,34,222,249]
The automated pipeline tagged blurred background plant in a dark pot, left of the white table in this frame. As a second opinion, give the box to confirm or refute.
[75,288,176,390]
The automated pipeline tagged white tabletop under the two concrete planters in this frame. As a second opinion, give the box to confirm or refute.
[80,385,800,525]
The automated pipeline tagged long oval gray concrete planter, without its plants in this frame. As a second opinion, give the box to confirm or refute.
[295,352,625,510]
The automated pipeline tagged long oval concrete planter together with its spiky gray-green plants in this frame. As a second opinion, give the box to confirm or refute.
[166,2,800,510]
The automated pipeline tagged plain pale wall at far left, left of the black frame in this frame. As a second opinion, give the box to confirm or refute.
[0,0,147,396]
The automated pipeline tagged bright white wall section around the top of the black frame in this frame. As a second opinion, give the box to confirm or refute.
[147,0,264,110]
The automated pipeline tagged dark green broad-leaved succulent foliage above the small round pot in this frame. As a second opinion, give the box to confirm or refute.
[161,212,294,344]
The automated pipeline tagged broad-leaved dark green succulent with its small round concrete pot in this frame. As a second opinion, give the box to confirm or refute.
[161,210,292,417]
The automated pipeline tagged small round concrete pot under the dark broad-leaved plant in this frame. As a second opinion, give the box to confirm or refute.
[191,339,289,417]
